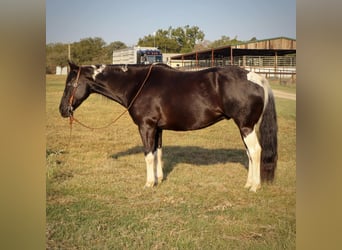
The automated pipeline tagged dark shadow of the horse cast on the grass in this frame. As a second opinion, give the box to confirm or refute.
[111,146,248,178]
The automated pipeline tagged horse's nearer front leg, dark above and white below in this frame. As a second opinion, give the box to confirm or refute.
[139,125,158,187]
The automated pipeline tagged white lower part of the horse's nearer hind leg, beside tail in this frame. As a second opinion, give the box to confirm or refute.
[243,129,261,192]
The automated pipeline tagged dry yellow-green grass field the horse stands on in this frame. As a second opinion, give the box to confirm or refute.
[46,75,296,249]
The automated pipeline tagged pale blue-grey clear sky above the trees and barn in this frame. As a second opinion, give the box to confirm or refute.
[46,0,296,46]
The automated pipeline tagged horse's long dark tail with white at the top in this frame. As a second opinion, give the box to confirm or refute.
[259,78,278,182]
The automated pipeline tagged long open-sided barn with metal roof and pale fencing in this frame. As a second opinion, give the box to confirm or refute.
[170,37,296,80]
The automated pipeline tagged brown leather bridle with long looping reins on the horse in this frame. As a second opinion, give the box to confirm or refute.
[69,63,156,130]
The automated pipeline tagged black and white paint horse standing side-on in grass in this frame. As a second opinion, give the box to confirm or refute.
[59,61,278,192]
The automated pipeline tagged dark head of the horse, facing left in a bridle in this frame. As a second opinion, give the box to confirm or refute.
[59,62,96,117]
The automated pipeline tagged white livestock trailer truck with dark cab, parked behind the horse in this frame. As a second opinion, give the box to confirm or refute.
[113,46,163,64]
